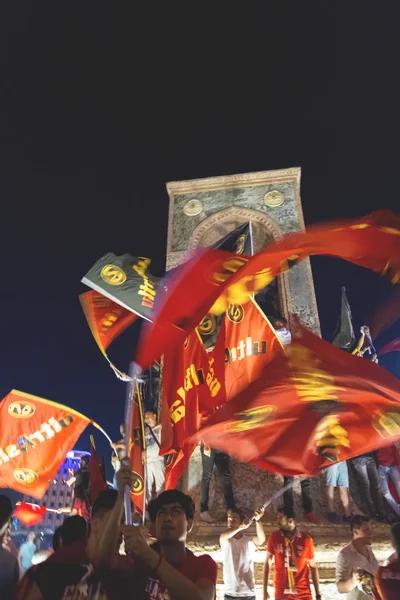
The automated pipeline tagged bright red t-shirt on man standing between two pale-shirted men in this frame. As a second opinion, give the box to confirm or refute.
[267,529,314,600]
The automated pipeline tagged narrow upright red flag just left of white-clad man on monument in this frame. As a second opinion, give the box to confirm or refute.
[130,398,146,515]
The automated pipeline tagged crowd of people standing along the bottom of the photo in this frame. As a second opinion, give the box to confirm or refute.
[0,466,400,600]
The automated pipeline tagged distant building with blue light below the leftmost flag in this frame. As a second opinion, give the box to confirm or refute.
[19,450,89,534]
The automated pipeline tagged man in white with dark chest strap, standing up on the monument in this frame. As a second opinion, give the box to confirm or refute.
[144,410,165,506]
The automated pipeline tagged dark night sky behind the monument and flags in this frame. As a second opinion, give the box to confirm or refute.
[0,1,400,502]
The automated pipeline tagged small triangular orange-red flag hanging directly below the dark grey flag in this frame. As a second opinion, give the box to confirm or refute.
[79,290,138,358]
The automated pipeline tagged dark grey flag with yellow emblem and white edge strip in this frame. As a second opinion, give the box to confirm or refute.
[82,252,159,322]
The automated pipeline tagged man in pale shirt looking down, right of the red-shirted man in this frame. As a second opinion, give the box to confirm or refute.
[336,515,379,600]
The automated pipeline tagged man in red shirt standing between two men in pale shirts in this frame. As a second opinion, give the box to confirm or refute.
[264,506,321,600]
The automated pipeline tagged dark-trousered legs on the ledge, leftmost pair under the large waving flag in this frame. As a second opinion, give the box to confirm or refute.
[200,444,235,523]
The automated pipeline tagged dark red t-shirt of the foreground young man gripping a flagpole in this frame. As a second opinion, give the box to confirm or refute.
[143,550,218,600]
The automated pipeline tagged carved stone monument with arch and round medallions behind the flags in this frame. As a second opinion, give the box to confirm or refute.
[167,168,325,516]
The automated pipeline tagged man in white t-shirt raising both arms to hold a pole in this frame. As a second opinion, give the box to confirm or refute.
[220,508,265,600]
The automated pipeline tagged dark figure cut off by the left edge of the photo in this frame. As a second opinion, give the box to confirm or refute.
[0,495,19,600]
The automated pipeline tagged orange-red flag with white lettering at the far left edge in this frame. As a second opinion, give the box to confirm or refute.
[0,390,91,498]
